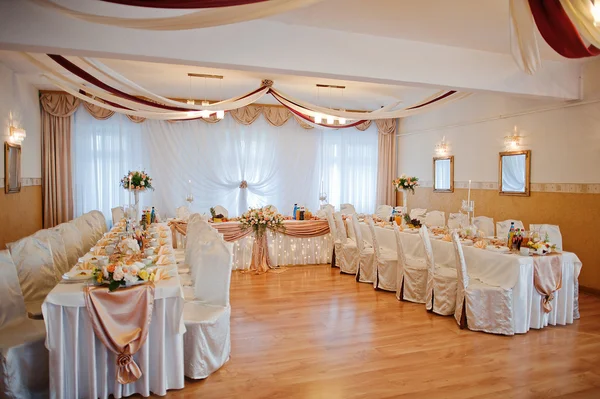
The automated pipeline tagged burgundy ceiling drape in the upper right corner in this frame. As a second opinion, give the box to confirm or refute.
[529,0,600,58]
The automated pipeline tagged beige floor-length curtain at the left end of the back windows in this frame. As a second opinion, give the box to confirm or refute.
[40,93,80,228]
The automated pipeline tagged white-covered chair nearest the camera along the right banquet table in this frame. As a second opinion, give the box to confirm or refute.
[452,232,515,335]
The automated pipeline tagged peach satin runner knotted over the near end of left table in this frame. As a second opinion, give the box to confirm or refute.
[84,283,154,384]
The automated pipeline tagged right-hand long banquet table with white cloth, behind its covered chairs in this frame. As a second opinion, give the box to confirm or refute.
[361,223,582,333]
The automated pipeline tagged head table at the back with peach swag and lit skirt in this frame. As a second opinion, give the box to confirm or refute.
[172,220,333,270]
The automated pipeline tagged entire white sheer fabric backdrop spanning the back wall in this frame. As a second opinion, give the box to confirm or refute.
[73,110,378,216]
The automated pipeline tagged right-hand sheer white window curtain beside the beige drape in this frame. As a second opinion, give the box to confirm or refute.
[321,123,378,213]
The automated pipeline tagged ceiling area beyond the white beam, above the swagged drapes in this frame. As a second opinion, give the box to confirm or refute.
[0,51,437,110]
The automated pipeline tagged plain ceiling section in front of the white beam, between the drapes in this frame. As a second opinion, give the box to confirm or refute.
[270,0,564,60]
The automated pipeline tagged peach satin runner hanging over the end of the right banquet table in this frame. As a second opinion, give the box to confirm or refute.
[533,254,563,313]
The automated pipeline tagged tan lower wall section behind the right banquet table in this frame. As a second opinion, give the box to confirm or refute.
[397,189,600,290]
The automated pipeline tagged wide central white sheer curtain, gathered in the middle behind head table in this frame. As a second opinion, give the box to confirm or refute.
[142,116,320,216]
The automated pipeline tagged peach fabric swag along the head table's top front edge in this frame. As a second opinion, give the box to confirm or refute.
[169,220,329,248]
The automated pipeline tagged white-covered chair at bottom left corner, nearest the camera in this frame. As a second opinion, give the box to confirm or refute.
[0,250,49,398]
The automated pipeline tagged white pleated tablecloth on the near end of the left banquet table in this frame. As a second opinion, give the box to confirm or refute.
[42,223,185,399]
